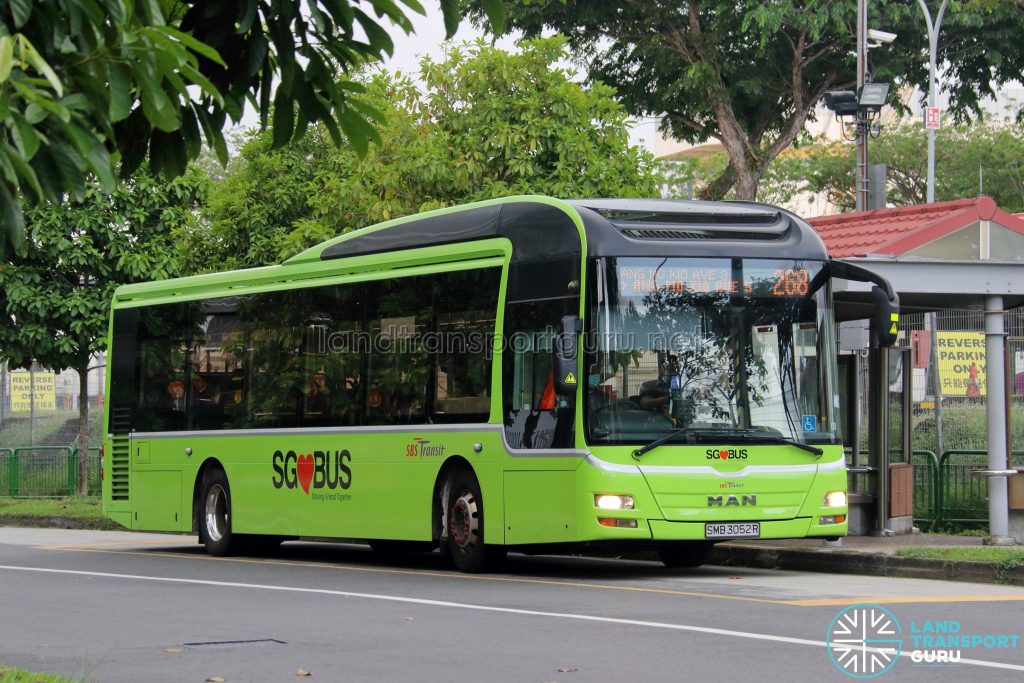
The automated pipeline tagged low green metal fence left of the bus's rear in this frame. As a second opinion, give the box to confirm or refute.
[0,445,100,498]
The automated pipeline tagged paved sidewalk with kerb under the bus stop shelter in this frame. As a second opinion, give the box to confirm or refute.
[709,533,1024,586]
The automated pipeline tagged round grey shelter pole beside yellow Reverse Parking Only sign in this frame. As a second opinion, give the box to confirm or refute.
[985,296,1015,546]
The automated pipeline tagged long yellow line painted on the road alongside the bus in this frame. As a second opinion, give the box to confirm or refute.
[37,539,1024,607]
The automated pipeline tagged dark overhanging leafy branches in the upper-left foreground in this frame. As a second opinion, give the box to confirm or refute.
[0,0,502,249]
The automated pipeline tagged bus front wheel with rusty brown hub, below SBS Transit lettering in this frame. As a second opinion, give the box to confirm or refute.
[445,469,505,573]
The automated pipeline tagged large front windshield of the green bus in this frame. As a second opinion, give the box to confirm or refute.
[584,257,841,444]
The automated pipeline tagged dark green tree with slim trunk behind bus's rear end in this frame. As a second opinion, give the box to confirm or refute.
[0,169,207,495]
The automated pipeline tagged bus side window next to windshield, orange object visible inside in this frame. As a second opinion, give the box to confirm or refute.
[502,299,575,449]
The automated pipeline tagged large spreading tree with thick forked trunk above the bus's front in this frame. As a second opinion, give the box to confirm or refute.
[468,0,1024,200]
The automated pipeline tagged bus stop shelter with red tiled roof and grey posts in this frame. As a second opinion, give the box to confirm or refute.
[809,197,1024,544]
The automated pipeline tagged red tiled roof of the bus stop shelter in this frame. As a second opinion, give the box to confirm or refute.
[807,197,1024,258]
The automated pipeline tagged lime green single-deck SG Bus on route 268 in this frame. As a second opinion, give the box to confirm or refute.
[103,197,896,571]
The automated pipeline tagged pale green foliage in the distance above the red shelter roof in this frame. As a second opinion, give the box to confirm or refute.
[764,120,1024,212]
